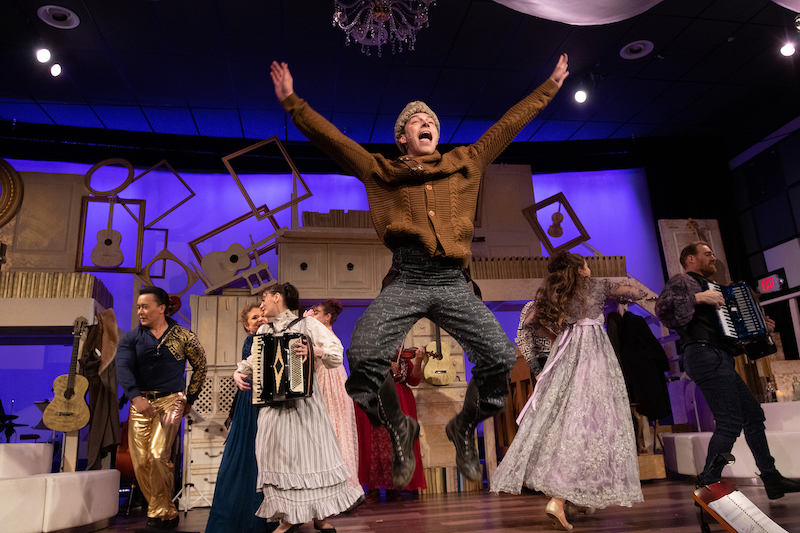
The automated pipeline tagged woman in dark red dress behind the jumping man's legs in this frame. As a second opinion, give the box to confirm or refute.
[356,348,426,503]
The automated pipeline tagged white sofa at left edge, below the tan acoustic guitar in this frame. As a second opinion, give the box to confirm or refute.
[0,443,119,533]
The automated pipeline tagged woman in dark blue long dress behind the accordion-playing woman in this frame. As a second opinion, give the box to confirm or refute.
[206,303,275,533]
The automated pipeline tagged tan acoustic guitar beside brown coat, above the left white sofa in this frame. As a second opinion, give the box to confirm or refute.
[42,316,89,432]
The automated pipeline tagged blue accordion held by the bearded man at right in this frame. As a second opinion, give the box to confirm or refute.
[708,282,777,359]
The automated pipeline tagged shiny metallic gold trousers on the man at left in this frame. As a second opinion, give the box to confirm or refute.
[128,392,186,520]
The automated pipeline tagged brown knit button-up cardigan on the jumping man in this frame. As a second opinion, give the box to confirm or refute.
[282,79,558,267]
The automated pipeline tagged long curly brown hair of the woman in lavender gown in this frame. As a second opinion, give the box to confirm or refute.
[532,252,586,333]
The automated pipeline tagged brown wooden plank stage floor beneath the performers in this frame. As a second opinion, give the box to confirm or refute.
[108,481,800,533]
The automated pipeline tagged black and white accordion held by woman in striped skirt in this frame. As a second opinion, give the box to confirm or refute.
[250,332,314,405]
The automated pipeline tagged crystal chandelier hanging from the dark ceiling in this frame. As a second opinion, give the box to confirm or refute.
[333,0,435,57]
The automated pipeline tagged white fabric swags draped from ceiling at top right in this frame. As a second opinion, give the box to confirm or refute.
[495,0,800,26]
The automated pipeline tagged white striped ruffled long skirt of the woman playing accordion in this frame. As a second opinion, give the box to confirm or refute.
[256,391,363,524]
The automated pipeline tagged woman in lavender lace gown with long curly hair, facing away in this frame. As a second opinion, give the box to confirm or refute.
[491,253,644,530]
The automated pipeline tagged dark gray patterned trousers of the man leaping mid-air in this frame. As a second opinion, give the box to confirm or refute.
[346,248,516,425]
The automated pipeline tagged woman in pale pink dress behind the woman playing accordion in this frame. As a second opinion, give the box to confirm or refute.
[303,299,361,488]
